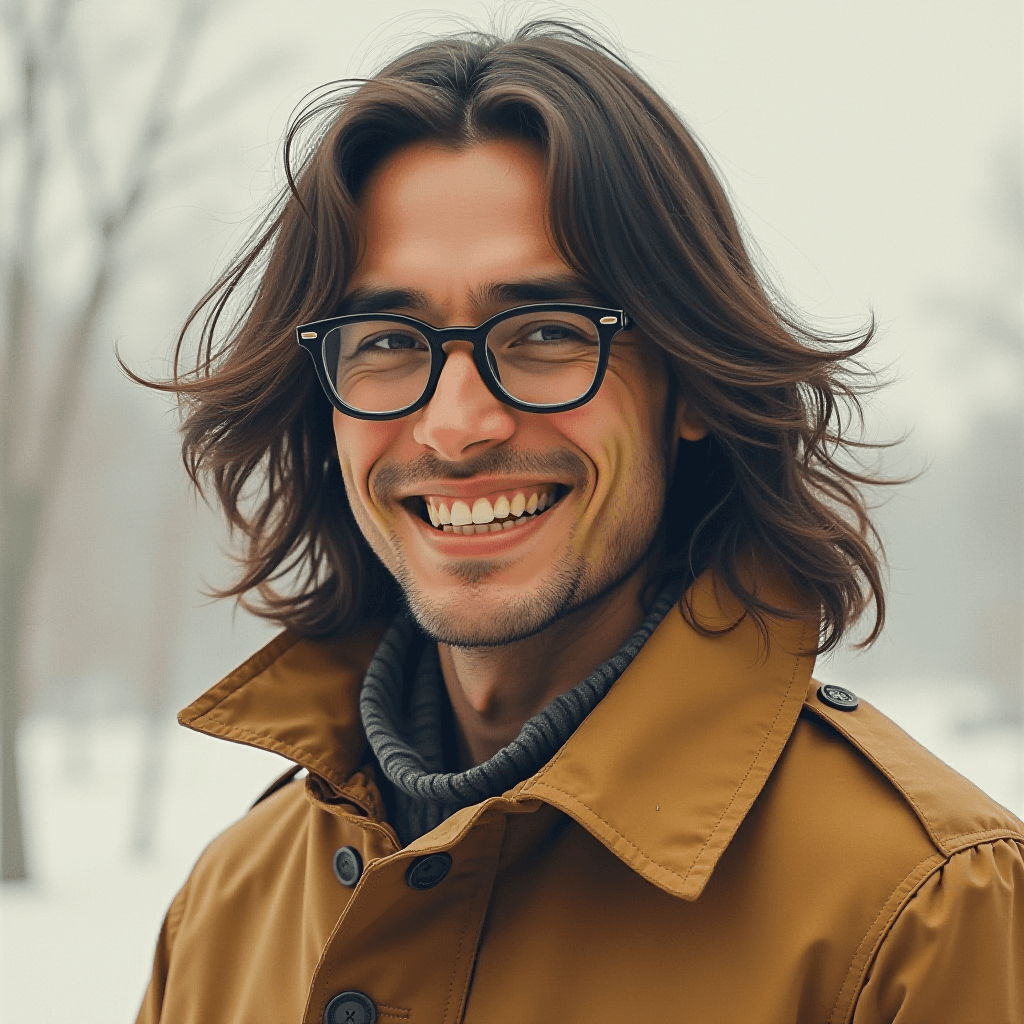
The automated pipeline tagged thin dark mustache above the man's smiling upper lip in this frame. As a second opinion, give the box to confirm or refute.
[373,447,588,502]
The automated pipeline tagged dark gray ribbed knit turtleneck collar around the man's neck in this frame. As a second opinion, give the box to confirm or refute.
[359,581,681,845]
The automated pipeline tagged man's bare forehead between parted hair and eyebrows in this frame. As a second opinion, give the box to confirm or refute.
[349,139,569,305]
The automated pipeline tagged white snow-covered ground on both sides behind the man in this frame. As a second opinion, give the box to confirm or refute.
[0,680,1024,1024]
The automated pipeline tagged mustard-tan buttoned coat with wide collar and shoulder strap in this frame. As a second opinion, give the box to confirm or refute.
[138,577,1024,1024]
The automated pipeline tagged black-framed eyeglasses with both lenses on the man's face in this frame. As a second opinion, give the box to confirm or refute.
[296,302,633,420]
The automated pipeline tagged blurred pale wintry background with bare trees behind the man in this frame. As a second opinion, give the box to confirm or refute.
[0,0,1024,1024]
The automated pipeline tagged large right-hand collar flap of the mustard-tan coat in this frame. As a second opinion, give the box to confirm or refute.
[519,577,817,900]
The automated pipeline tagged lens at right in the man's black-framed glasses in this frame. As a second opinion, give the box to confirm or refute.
[486,312,601,406]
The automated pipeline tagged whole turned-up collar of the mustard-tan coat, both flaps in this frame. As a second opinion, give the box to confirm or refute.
[178,574,817,899]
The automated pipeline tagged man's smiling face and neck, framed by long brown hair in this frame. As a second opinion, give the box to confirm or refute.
[319,138,705,766]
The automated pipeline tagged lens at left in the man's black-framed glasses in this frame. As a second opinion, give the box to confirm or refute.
[324,319,430,413]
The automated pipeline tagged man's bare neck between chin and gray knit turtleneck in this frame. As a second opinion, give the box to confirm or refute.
[437,572,644,770]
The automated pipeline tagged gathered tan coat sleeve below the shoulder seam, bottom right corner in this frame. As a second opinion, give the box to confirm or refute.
[852,840,1024,1024]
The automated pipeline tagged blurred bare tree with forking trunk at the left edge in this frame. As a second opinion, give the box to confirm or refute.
[0,0,218,881]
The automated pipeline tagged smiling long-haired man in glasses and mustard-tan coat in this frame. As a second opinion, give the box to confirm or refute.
[139,24,1024,1024]
